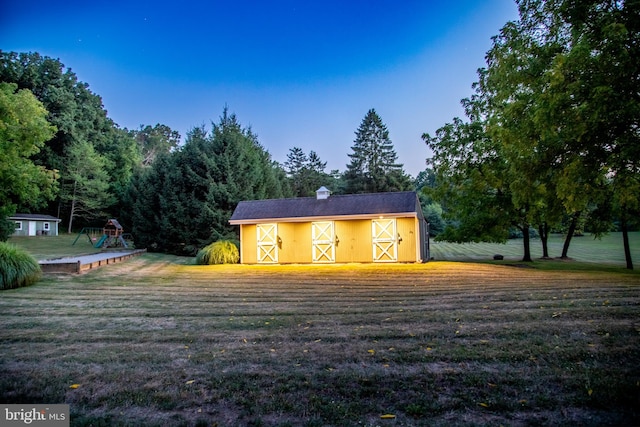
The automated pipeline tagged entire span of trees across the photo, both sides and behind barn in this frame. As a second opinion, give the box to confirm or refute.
[0,0,640,268]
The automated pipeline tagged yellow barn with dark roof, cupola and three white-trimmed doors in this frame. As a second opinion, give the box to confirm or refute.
[229,187,429,264]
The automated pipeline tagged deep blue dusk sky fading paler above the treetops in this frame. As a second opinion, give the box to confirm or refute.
[0,0,517,176]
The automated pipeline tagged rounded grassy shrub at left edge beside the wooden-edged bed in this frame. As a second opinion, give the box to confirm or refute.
[0,242,42,289]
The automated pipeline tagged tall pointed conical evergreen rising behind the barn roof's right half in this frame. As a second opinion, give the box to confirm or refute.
[344,109,411,194]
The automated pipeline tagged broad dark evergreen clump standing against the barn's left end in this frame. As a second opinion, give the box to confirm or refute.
[127,108,290,255]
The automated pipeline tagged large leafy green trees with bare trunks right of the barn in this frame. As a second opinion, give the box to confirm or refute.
[423,0,640,269]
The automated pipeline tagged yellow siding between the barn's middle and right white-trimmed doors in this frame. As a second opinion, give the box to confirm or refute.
[335,219,373,262]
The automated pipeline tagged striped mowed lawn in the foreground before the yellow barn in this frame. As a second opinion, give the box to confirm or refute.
[0,236,640,426]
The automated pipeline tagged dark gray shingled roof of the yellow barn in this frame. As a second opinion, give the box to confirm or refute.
[229,191,423,224]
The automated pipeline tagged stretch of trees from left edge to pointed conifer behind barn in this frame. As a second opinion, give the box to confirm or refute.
[0,52,420,255]
